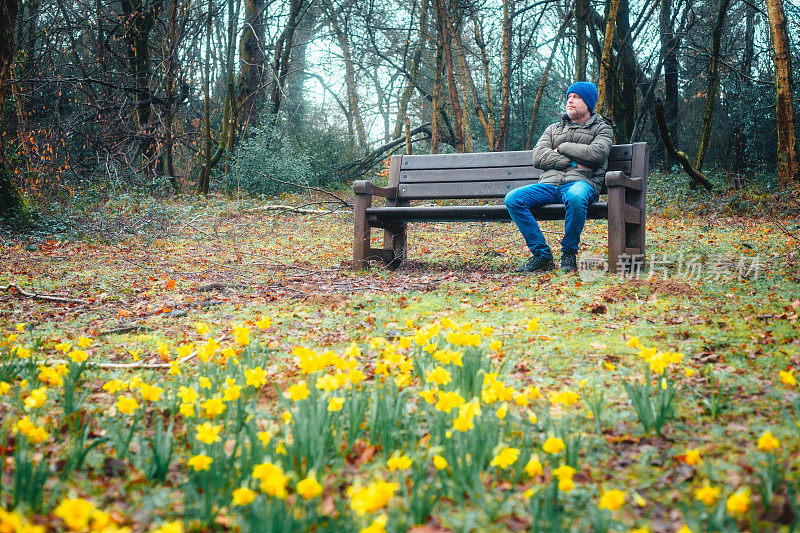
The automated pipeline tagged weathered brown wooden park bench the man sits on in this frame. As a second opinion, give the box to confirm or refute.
[353,143,649,272]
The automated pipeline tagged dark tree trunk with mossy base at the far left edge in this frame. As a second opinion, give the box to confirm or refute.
[0,0,30,222]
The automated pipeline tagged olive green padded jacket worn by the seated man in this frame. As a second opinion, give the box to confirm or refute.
[533,113,614,194]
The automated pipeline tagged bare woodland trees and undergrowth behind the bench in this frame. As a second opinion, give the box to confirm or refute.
[0,0,800,220]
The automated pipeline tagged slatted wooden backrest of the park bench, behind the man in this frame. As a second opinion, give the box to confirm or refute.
[389,144,633,202]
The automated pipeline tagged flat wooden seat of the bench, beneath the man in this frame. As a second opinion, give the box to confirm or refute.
[367,202,608,224]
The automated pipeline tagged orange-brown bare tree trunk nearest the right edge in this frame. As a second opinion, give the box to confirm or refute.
[766,0,800,183]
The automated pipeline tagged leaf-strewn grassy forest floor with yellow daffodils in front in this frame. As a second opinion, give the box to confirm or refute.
[0,177,800,532]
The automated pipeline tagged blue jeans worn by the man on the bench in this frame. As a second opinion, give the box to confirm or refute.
[505,181,599,257]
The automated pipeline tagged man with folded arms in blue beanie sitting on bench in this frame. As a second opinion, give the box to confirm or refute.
[505,81,614,272]
